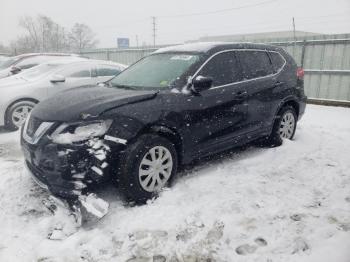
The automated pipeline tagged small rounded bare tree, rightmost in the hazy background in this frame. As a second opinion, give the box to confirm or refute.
[69,23,97,52]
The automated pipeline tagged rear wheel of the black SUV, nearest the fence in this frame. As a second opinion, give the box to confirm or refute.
[258,106,298,147]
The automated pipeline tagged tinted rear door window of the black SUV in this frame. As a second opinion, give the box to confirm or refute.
[237,51,273,79]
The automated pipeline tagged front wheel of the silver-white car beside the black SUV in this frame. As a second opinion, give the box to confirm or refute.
[5,101,35,131]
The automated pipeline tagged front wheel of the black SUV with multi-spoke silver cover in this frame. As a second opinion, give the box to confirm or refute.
[117,134,178,204]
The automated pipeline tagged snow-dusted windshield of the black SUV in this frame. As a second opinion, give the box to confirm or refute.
[109,53,200,90]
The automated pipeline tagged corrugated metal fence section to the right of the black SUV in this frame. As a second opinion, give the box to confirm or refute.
[275,37,350,101]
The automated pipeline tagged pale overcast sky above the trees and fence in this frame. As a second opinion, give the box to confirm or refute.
[0,0,350,47]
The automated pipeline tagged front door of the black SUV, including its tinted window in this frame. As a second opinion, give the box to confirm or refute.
[182,51,249,158]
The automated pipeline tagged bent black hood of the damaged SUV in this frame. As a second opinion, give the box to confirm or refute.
[32,86,157,122]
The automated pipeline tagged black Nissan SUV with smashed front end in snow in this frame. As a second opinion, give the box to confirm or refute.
[21,43,306,203]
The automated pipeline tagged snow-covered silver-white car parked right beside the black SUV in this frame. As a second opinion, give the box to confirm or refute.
[0,58,126,130]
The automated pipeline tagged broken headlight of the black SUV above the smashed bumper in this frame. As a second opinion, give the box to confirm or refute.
[51,120,112,144]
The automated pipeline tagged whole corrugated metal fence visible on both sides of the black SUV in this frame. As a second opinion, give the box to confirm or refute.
[82,34,350,101]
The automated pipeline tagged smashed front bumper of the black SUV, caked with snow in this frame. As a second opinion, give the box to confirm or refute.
[22,135,123,198]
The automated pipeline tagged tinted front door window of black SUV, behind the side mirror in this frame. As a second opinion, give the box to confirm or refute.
[199,52,241,86]
